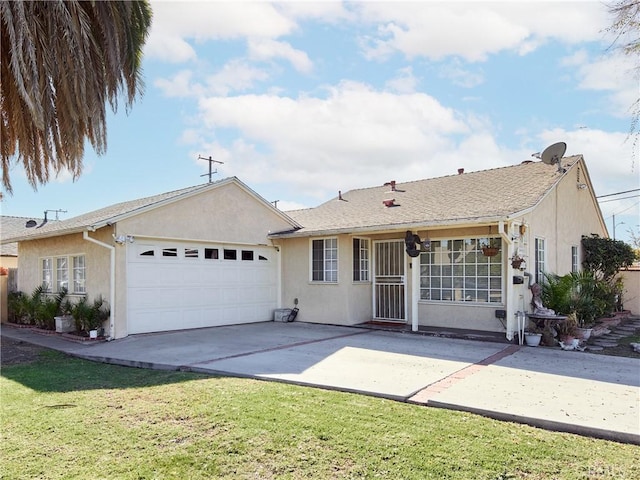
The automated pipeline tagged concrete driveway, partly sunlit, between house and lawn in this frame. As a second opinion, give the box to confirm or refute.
[1,322,640,445]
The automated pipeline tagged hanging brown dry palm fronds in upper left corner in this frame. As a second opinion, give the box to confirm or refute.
[0,0,152,193]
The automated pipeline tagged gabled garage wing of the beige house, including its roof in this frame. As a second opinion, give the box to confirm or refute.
[2,178,299,338]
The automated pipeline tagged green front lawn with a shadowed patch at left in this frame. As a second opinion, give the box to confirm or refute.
[0,352,640,480]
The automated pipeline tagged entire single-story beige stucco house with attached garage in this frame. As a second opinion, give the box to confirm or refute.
[3,155,607,339]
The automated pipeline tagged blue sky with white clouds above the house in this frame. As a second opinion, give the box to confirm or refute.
[2,1,640,244]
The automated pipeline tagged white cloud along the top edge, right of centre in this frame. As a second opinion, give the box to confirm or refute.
[357,2,606,62]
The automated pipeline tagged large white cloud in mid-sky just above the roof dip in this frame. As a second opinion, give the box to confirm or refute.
[195,82,480,198]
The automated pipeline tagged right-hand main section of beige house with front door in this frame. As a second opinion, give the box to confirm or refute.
[270,156,607,339]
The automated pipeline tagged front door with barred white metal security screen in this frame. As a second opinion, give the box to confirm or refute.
[373,240,407,322]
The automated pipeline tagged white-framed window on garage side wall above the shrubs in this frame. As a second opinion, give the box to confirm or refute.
[40,253,87,295]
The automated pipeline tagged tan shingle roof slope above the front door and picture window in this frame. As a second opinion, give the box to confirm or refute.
[273,155,582,236]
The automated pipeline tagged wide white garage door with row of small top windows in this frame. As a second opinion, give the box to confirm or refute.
[127,240,277,334]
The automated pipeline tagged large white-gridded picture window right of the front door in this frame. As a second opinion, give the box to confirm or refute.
[420,237,503,303]
